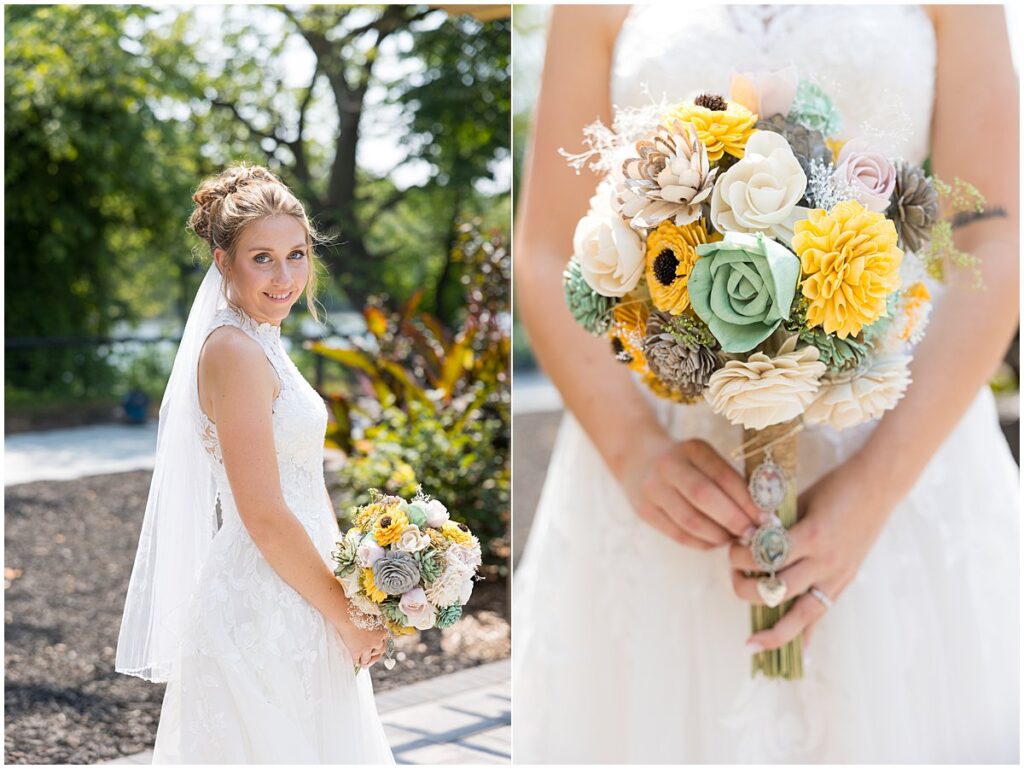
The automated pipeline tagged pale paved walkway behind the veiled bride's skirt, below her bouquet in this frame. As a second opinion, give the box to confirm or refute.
[104,659,512,764]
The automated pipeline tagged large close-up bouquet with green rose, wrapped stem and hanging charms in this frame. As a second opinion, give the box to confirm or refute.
[563,68,983,678]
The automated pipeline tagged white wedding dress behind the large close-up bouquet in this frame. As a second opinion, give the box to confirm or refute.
[513,3,1019,763]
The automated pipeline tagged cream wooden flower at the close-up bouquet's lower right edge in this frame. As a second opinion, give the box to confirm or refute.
[804,355,910,430]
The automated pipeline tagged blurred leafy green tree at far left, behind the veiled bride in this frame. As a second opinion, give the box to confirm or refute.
[4,6,200,393]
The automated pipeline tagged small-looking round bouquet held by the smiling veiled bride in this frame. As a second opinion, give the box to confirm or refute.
[334,488,482,670]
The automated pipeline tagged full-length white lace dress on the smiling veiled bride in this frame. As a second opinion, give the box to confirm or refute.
[154,308,393,764]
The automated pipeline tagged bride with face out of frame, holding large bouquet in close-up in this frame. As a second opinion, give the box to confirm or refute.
[513,4,1019,763]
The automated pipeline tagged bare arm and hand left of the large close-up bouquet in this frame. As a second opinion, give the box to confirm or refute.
[514,6,756,547]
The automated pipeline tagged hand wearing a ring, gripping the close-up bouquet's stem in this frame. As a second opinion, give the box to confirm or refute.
[729,458,895,649]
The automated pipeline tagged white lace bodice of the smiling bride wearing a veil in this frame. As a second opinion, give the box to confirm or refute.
[197,307,328,525]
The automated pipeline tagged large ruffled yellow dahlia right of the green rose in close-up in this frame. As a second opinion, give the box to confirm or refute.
[793,201,903,339]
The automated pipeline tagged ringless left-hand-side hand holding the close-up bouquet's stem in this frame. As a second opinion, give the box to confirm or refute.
[622,436,759,550]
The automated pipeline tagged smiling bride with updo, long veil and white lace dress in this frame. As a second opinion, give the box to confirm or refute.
[116,166,393,764]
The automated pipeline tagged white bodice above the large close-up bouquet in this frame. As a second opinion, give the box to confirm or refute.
[611,3,935,163]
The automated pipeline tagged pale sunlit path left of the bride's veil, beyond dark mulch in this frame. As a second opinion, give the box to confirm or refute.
[3,420,157,486]
